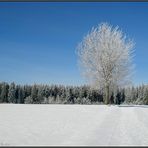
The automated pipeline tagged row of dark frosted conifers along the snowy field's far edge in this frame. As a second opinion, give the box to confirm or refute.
[0,82,148,104]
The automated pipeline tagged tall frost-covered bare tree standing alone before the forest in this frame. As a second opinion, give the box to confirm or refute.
[78,23,133,104]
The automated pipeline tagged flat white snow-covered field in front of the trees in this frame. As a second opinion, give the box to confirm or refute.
[0,104,148,146]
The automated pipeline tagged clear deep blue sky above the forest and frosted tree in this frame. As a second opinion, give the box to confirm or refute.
[0,2,148,85]
